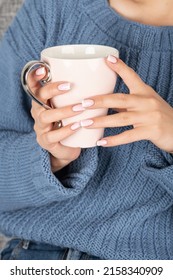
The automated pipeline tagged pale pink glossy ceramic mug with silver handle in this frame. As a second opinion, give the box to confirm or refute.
[22,45,119,148]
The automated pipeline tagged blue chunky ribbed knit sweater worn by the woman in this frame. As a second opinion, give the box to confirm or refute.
[0,0,173,259]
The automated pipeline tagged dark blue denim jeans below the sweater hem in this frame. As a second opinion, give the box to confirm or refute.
[0,239,99,260]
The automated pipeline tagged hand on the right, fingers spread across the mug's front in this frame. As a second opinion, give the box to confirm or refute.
[81,56,173,153]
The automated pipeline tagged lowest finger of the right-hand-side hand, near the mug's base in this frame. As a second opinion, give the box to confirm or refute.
[97,127,150,147]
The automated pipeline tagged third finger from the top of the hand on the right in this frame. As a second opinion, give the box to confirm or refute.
[81,112,147,128]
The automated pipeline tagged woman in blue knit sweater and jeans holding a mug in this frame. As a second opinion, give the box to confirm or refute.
[0,0,173,259]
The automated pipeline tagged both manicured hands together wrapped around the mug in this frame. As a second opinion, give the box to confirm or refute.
[30,56,173,172]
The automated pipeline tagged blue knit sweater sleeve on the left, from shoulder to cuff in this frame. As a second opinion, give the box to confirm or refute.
[0,0,97,212]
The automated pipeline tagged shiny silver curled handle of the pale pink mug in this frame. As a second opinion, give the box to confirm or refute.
[21,60,52,110]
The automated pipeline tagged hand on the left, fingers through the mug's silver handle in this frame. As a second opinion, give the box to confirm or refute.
[28,67,84,172]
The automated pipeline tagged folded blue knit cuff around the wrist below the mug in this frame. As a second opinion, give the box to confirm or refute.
[31,138,98,203]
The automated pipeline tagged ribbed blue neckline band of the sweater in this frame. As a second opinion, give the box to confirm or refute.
[83,0,173,51]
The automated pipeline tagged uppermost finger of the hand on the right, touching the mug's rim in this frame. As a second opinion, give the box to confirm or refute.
[106,55,145,93]
